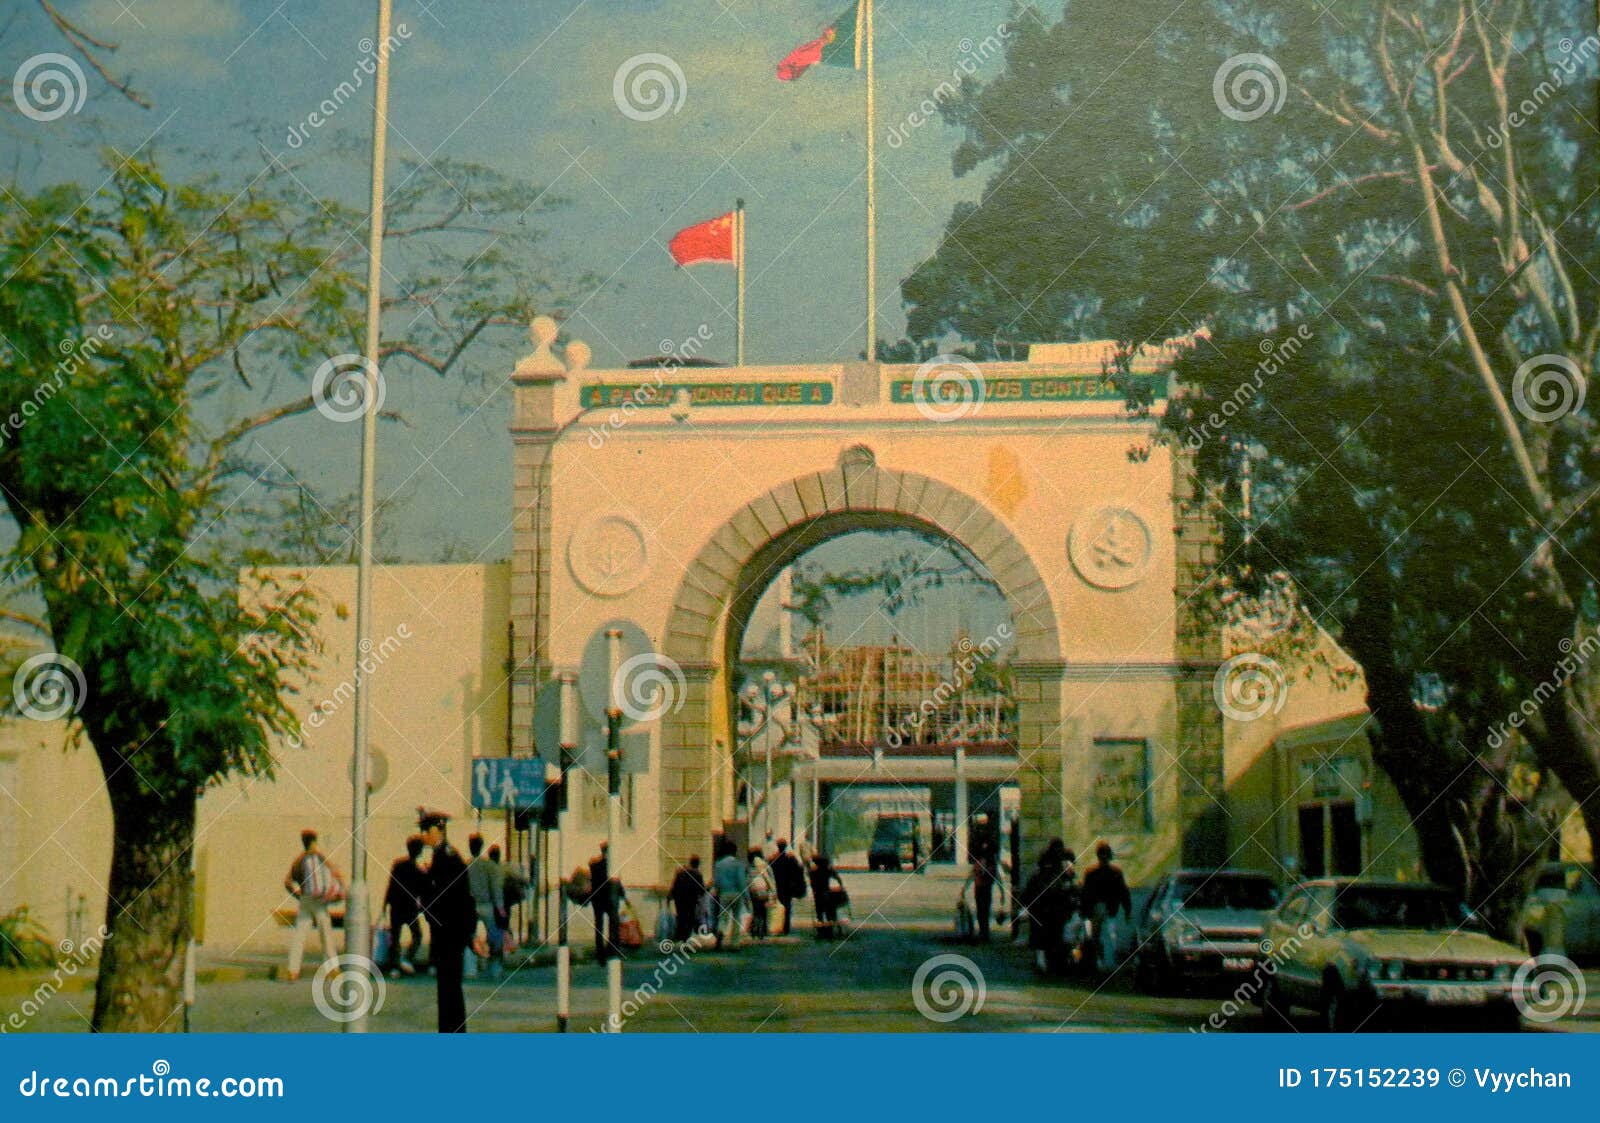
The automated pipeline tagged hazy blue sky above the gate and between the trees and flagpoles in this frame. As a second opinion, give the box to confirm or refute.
[0,0,1024,582]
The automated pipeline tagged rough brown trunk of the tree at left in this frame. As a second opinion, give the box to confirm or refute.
[93,777,195,1033]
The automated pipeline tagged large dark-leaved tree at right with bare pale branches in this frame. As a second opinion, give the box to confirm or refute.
[904,0,1600,925]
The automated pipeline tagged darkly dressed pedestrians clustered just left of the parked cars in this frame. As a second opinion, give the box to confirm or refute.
[1018,838,1133,974]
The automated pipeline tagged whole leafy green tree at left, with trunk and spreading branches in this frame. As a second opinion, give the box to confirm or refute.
[0,152,588,1030]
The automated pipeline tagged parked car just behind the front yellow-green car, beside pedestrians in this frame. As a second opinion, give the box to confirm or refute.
[1134,870,1282,992]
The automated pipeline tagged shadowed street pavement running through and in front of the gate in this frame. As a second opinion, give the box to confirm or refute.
[12,872,1600,1033]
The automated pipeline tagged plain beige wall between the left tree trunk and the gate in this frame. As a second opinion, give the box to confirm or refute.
[197,565,509,953]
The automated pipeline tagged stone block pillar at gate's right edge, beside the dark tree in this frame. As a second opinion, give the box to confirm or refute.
[1173,451,1230,865]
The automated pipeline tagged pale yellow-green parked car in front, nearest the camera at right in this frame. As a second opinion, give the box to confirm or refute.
[1258,878,1528,1032]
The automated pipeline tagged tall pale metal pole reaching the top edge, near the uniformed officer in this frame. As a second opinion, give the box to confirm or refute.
[344,0,390,1033]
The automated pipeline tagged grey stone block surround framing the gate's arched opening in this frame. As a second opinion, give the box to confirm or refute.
[643,445,1062,872]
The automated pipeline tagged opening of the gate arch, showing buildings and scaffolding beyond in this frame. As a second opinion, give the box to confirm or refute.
[725,524,1021,873]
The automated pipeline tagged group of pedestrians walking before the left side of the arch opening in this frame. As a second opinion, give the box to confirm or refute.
[661,838,850,950]
